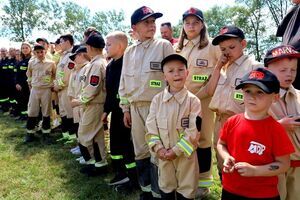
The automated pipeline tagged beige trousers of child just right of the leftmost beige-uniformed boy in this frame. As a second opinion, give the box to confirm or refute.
[58,88,73,118]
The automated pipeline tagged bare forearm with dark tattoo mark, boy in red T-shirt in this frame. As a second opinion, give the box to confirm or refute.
[234,155,290,177]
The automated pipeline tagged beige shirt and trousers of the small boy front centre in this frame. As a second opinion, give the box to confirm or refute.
[146,88,201,198]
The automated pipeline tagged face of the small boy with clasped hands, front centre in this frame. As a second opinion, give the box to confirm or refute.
[164,60,188,92]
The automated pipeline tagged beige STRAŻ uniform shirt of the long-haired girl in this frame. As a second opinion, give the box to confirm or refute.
[179,36,221,94]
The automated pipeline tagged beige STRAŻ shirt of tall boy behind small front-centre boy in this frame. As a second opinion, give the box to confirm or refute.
[119,39,174,111]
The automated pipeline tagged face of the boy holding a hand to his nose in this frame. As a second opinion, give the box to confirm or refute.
[219,38,247,63]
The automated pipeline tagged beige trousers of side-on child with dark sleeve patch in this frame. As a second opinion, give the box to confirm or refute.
[78,104,106,160]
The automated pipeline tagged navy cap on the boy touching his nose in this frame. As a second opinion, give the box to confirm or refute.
[212,26,245,45]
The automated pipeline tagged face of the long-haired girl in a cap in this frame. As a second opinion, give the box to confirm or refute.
[183,16,203,40]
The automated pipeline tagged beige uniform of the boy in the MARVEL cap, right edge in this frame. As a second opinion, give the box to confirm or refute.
[270,86,300,160]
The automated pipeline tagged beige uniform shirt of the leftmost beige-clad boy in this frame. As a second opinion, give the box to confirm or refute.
[26,58,55,88]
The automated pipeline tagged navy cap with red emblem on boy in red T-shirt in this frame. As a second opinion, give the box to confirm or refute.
[235,68,280,94]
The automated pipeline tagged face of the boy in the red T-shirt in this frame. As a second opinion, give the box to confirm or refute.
[243,84,278,115]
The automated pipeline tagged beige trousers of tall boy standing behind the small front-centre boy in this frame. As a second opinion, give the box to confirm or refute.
[130,102,150,160]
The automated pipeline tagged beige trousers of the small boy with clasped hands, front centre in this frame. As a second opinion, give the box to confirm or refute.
[158,152,199,199]
